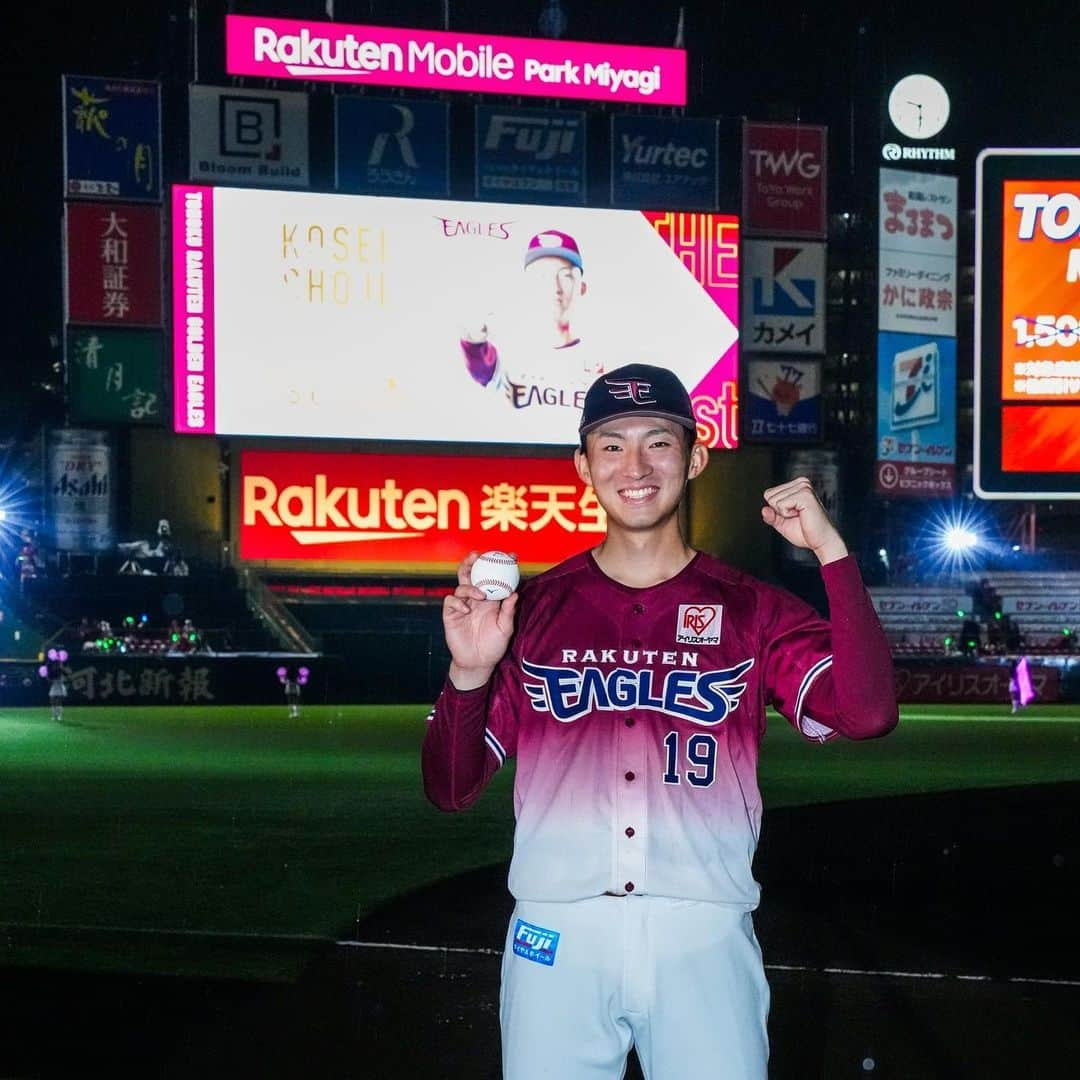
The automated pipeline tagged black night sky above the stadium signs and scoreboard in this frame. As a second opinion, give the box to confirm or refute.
[6,0,1080,435]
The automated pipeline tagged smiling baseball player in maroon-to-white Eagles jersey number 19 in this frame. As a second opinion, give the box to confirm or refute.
[422,364,897,1080]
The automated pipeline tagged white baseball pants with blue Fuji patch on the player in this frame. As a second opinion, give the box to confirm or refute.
[500,895,769,1080]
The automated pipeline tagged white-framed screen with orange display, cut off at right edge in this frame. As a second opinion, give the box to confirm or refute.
[974,149,1080,499]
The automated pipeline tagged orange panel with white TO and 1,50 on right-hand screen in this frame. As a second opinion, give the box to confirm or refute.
[1001,179,1080,403]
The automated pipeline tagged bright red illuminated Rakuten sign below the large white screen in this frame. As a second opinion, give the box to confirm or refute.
[239,450,607,573]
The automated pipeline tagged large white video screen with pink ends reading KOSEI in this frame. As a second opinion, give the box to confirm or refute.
[172,186,739,447]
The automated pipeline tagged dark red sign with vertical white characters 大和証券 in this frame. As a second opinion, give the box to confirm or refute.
[65,203,161,326]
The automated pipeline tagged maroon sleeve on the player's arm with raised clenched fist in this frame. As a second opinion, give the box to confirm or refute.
[762,555,897,742]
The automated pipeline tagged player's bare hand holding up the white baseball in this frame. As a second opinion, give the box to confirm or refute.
[443,551,517,690]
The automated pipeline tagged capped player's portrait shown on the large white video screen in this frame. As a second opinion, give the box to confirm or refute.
[461,229,604,410]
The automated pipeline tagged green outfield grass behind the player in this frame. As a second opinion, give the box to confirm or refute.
[0,705,1080,980]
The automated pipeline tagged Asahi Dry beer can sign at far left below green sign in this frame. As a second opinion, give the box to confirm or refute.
[48,429,116,554]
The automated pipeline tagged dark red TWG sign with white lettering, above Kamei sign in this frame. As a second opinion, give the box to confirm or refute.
[743,121,828,237]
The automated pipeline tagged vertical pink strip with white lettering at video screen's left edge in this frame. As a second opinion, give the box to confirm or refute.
[173,185,216,435]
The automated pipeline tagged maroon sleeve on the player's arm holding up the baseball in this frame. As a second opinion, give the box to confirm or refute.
[420,653,517,811]
